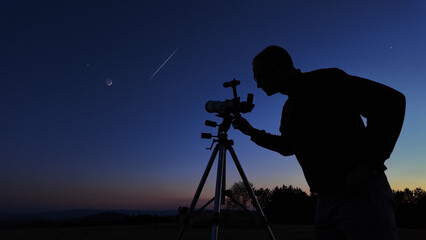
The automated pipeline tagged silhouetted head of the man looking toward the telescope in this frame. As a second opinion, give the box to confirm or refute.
[252,46,296,96]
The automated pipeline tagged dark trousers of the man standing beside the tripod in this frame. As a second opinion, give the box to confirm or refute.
[314,173,397,240]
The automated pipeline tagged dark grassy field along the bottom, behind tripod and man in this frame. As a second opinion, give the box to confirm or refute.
[0,224,426,240]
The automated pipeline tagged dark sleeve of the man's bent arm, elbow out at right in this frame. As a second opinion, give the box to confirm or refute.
[349,76,405,169]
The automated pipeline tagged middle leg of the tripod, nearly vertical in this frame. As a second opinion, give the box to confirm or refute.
[211,144,226,240]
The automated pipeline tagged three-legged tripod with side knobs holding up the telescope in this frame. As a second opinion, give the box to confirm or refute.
[176,114,275,240]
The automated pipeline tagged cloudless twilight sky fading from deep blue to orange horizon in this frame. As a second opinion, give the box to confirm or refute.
[0,0,426,212]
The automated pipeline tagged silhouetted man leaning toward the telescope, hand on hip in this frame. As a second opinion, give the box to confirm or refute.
[233,46,405,240]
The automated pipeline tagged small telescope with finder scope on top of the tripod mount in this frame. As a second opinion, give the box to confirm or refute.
[206,78,254,115]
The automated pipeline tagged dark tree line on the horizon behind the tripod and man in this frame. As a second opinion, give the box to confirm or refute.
[221,182,426,228]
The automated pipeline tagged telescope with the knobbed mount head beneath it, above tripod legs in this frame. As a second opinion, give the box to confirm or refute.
[201,78,254,149]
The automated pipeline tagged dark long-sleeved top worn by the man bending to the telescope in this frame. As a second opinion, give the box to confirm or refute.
[252,68,405,193]
